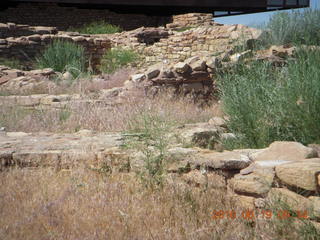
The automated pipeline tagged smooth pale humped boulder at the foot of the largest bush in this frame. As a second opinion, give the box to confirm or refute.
[250,142,317,162]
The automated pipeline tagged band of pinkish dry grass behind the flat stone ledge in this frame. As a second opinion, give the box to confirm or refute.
[0,91,221,132]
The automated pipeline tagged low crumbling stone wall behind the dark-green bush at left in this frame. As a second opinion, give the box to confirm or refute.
[0,24,111,70]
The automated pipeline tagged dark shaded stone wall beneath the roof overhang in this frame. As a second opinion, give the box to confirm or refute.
[0,3,171,31]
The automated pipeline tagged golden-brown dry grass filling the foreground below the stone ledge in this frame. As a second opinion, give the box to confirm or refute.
[0,167,316,240]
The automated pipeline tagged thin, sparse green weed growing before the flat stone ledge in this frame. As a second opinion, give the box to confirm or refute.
[125,112,173,189]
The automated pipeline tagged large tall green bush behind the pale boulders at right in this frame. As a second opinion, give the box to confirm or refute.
[219,49,320,148]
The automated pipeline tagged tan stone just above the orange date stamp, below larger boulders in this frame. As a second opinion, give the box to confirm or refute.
[267,188,312,212]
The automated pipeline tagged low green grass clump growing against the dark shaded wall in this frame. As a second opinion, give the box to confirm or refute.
[69,21,122,34]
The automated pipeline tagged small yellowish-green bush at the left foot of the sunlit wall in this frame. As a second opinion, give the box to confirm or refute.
[100,48,139,73]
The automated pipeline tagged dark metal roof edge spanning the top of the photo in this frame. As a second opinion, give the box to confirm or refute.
[8,0,310,17]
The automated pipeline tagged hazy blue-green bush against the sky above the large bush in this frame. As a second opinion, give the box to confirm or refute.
[264,9,320,45]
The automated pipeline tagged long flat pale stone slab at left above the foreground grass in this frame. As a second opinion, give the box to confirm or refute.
[0,130,122,167]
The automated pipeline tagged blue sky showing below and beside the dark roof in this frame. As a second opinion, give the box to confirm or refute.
[215,0,320,25]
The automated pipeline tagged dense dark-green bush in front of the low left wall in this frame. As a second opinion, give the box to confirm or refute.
[36,40,85,77]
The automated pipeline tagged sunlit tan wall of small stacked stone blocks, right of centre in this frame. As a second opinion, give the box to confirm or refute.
[110,22,261,65]
